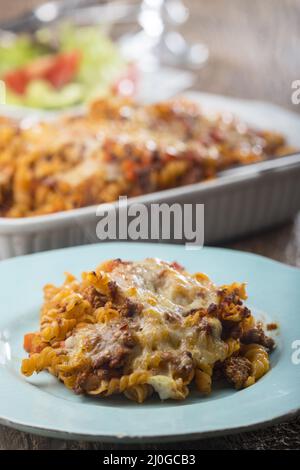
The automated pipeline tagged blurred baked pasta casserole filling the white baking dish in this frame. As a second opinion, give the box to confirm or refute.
[0,98,290,217]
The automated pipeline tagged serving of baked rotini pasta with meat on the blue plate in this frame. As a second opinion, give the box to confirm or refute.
[22,259,274,403]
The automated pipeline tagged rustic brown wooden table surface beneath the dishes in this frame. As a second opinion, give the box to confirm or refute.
[0,0,300,450]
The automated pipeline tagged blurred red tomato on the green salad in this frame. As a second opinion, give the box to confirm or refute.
[4,51,81,95]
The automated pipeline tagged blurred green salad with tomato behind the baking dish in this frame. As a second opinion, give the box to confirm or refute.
[0,25,136,109]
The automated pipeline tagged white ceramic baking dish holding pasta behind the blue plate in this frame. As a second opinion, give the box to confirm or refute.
[0,93,300,259]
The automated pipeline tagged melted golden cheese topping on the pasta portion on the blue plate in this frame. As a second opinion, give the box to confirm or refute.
[66,259,227,399]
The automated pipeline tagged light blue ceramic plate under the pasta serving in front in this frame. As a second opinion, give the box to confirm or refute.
[0,243,300,442]
